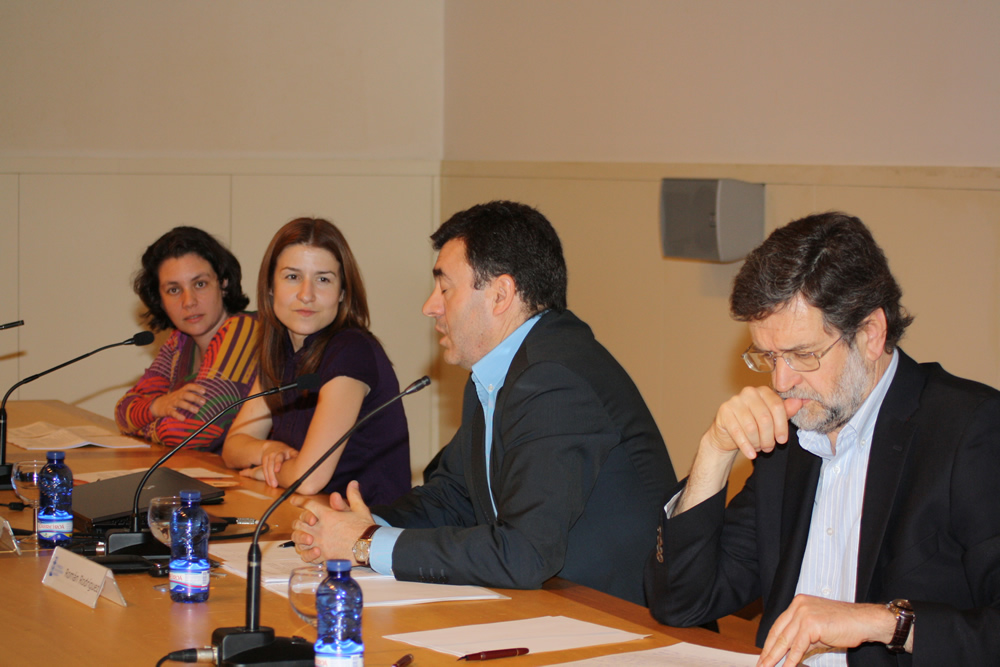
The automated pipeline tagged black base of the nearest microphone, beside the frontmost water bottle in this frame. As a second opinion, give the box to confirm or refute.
[212,628,316,667]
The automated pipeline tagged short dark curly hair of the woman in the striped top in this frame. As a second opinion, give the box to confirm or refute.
[132,227,250,331]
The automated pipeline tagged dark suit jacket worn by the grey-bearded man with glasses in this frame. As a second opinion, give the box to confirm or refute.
[647,351,1000,665]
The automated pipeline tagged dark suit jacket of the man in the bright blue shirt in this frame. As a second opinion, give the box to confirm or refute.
[373,311,676,604]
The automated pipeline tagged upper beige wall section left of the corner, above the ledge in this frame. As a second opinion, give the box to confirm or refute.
[0,0,444,159]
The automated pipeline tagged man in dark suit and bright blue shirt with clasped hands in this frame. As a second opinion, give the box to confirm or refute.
[293,202,676,604]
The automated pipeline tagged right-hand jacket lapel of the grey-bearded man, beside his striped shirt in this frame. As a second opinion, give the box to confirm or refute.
[854,349,926,602]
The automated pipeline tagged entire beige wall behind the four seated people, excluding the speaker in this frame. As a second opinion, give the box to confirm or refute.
[0,0,1000,482]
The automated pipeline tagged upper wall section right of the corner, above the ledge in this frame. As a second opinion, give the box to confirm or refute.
[445,0,1000,167]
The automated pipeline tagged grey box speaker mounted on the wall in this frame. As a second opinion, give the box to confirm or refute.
[660,178,764,262]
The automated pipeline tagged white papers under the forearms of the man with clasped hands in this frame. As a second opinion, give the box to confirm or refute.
[208,540,509,607]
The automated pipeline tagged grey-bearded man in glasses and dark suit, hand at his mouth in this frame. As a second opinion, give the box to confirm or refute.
[647,213,1000,667]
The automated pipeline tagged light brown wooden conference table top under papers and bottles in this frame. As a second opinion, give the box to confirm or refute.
[0,401,757,667]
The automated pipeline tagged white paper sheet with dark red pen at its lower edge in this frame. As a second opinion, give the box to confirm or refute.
[385,616,649,657]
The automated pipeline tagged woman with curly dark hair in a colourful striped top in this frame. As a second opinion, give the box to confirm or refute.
[115,227,258,452]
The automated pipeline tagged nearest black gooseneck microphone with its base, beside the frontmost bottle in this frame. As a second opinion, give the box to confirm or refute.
[212,375,431,667]
